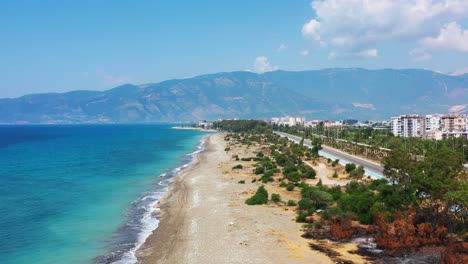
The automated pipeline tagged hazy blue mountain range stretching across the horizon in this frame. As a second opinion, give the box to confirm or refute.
[0,68,468,123]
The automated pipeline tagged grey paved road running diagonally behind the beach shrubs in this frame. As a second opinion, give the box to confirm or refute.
[275,131,383,178]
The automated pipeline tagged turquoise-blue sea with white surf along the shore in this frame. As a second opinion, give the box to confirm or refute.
[0,125,207,264]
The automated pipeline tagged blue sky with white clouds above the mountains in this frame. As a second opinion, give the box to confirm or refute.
[0,0,468,98]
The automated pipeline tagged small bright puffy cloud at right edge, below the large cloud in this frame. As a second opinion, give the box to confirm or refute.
[422,22,468,52]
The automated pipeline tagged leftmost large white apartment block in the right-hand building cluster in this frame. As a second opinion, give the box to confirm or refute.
[390,115,426,137]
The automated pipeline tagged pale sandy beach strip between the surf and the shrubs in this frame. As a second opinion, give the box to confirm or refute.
[137,134,334,264]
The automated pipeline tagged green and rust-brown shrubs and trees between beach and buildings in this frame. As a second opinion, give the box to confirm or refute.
[223,121,468,263]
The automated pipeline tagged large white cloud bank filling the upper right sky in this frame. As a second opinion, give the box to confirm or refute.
[302,0,468,59]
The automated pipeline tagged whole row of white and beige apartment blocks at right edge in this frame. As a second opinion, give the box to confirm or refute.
[390,114,468,140]
